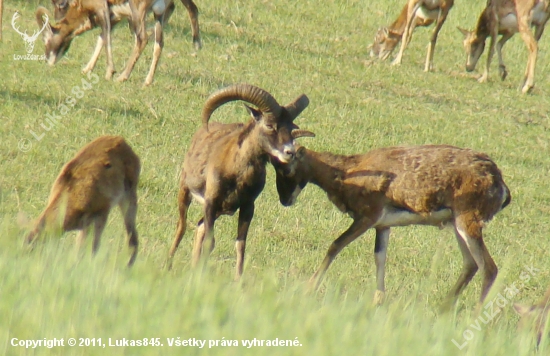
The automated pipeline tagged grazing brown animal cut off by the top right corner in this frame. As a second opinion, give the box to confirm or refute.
[459,0,550,93]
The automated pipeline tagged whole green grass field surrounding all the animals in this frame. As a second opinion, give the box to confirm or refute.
[0,0,550,355]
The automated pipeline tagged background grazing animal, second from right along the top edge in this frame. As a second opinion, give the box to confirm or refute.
[371,0,454,72]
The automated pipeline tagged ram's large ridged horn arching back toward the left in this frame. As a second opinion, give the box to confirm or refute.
[202,84,282,129]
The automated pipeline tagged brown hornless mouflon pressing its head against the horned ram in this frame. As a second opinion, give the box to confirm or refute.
[275,145,511,304]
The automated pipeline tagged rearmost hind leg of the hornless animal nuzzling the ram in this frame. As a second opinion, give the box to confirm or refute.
[455,213,498,305]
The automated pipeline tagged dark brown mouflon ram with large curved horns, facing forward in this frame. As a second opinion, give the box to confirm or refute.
[168,84,309,278]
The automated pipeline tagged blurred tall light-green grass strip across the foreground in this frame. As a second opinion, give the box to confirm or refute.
[0,220,545,355]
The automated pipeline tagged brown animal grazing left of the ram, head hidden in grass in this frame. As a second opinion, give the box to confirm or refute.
[26,136,140,266]
